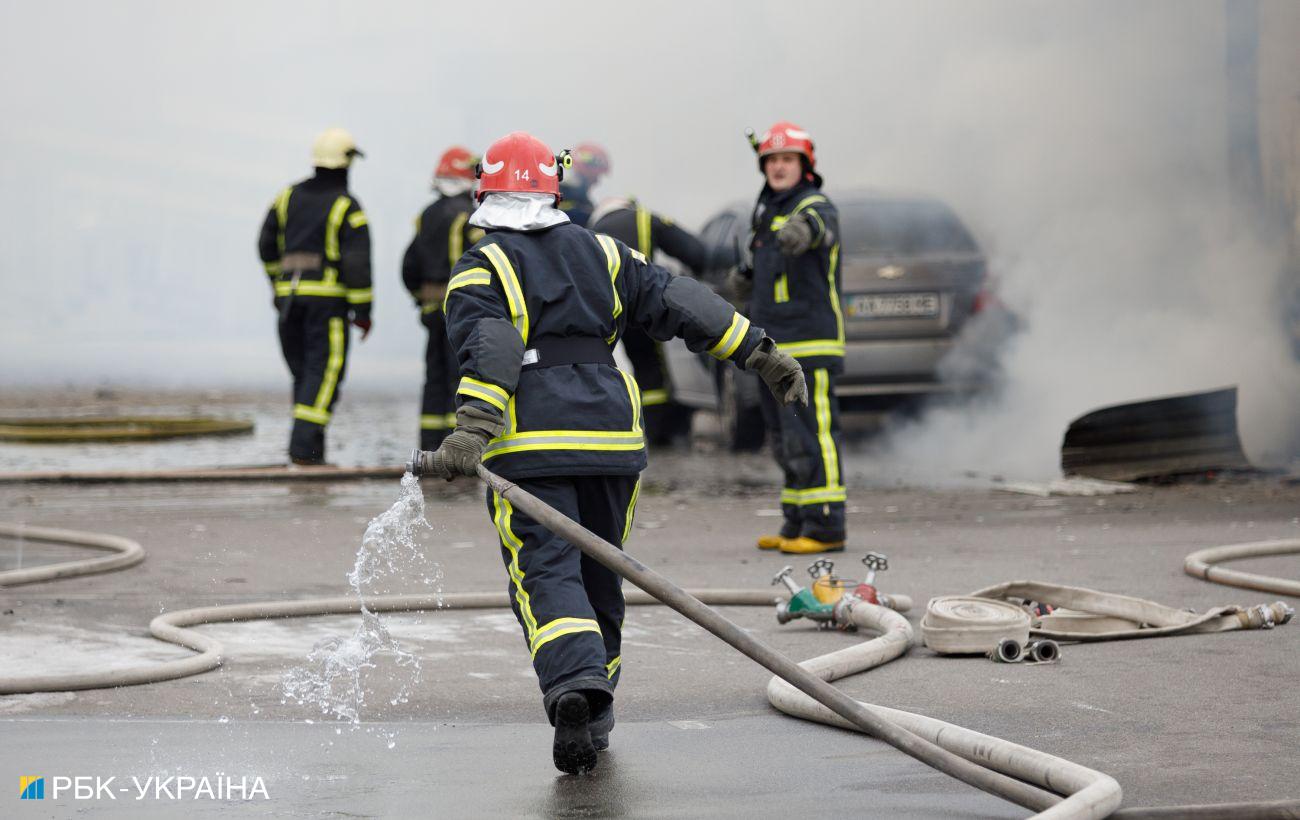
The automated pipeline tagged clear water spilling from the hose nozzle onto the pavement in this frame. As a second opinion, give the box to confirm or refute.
[281,473,442,749]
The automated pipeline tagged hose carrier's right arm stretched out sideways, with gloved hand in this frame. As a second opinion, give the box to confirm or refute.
[619,246,809,404]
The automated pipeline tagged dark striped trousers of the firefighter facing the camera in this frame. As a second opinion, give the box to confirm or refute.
[762,368,846,542]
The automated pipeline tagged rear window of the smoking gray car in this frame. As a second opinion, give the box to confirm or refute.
[840,200,979,256]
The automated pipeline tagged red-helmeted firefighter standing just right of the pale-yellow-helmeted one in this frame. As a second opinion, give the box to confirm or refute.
[402,146,484,450]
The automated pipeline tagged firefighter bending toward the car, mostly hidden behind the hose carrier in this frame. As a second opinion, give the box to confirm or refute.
[588,199,709,446]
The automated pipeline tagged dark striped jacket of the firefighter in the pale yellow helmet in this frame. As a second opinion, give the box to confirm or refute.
[257,168,373,320]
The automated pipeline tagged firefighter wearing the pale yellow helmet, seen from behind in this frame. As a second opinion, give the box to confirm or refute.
[257,129,372,464]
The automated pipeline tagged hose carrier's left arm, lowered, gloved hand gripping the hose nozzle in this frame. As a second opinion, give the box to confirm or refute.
[430,246,524,481]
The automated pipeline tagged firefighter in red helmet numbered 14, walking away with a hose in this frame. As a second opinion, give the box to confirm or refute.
[412,131,807,773]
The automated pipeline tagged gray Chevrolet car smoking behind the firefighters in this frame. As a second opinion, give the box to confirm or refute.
[666,191,1014,450]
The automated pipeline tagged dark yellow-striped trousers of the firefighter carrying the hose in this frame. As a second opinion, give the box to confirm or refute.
[488,476,641,732]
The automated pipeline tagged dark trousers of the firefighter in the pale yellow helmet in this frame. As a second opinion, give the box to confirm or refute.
[280,296,347,461]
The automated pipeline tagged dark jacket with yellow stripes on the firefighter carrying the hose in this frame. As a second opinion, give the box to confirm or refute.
[445,224,763,480]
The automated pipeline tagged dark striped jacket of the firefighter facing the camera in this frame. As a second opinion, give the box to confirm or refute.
[750,182,844,372]
